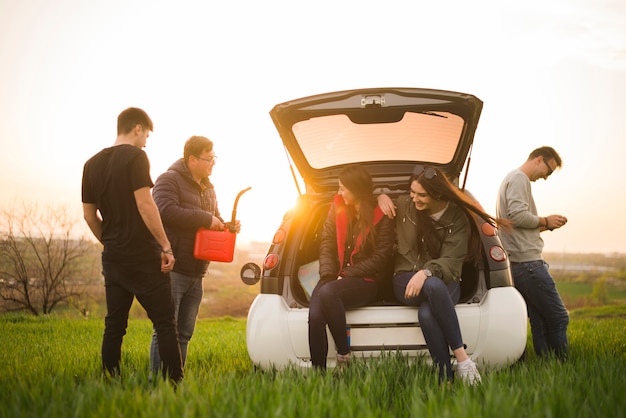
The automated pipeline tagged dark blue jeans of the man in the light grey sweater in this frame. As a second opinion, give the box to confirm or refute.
[511,260,569,359]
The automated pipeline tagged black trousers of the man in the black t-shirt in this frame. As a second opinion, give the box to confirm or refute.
[102,261,183,382]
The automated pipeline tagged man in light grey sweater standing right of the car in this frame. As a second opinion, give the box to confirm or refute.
[496,147,569,360]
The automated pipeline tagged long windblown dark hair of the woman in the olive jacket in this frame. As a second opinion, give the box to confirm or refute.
[409,165,510,263]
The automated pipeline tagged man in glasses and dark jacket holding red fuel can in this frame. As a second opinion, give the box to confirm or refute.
[150,136,239,373]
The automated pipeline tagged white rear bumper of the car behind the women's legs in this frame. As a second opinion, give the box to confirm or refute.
[246,287,527,369]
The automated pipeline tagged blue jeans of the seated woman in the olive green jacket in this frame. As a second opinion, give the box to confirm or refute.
[393,271,463,380]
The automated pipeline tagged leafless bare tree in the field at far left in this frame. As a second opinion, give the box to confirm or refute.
[0,203,99,315]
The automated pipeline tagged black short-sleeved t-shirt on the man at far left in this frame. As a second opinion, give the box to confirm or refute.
[82,145,160,262]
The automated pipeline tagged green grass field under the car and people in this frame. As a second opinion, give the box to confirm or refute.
[0,305,626,418]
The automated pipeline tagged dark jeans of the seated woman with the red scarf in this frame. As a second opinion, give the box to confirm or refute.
[309,277,378,369]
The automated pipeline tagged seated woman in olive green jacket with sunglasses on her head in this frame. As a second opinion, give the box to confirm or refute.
[379,165,504,384]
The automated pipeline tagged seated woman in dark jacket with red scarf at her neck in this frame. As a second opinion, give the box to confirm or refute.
[309,165,395,369]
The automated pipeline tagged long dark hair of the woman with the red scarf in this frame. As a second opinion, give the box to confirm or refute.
[339,165,377,242]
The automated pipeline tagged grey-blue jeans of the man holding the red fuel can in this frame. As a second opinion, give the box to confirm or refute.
[150,272,204,373]
